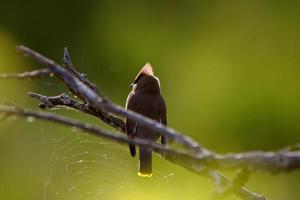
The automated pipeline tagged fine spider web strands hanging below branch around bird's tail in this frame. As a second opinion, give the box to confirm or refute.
[44,130,174,200]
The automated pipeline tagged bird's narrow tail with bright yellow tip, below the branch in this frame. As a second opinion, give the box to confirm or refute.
[138,148,152,177]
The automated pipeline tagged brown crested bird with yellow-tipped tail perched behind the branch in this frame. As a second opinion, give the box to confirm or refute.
[125,63,167,177]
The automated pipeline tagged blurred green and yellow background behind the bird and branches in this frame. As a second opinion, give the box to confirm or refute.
[0,0,300,200]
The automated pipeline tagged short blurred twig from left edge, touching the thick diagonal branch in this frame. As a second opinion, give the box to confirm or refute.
[0,68,51,79]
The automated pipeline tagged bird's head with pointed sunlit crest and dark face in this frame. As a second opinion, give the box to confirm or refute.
[130,63,160,93]
